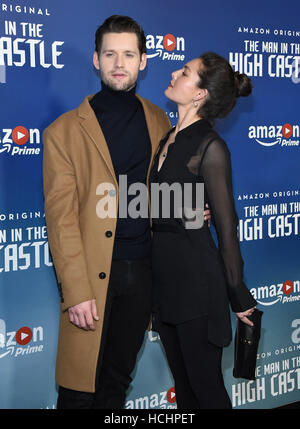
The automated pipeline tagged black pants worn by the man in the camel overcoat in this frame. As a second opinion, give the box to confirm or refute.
[57,259,152,409]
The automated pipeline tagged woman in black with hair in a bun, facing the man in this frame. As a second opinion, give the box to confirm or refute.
[150,52,256,408]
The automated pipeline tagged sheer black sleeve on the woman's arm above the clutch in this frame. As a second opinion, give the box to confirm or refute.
[199,137,257,312]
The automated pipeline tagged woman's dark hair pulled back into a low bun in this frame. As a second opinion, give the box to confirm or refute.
[197,52,252,120]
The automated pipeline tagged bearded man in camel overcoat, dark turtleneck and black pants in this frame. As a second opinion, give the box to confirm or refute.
[43,15,210,409]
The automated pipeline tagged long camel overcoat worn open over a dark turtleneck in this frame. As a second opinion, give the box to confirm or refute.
[43,95,170,392]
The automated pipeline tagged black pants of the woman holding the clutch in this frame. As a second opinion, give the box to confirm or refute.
[156,316,232,409]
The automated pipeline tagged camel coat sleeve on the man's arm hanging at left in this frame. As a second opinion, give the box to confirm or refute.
[43,125,94,310]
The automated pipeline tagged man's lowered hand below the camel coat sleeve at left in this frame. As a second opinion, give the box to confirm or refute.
[68,299,99,331]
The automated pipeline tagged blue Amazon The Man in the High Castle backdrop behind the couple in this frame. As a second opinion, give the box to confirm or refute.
[0,0,300,409]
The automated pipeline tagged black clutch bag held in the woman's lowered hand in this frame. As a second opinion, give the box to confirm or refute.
[233,309,263,380]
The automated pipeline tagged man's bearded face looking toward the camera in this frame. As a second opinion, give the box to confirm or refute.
[93,33,147,91]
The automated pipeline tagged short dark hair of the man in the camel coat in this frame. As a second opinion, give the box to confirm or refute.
[95,15,146,55]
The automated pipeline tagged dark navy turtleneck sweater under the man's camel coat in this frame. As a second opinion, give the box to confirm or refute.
[90,82,151,259]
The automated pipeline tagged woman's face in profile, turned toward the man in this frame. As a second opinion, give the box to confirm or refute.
[165,58,202,106]
